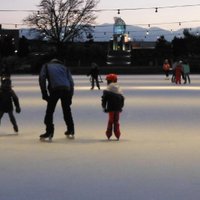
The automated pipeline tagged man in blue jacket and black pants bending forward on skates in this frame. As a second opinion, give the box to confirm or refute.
[39,58,75,141]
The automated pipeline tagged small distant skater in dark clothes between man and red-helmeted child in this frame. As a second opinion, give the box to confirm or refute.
[87,63,100,90]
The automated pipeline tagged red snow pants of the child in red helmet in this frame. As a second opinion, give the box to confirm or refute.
[106,112,121,139]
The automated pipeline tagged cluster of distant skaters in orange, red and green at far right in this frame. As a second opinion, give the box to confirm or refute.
[163,59,191,84]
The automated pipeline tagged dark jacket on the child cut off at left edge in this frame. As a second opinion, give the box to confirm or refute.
[0,88,20,113]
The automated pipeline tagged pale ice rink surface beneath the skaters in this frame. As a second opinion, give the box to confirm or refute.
[0,75,200,200]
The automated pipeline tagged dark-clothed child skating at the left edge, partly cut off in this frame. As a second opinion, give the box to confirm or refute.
[0,78,21,132]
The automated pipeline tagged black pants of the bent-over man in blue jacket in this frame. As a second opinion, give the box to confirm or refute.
[44,90,74,134]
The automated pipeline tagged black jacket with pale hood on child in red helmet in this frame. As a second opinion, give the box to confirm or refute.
[102,83,124,112]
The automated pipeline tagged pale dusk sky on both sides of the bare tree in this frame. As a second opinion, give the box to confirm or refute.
[0,0,200,30]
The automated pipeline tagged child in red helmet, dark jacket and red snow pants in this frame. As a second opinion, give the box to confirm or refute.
[102,74,124,140]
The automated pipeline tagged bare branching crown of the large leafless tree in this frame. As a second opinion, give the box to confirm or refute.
[24,0,99,50]
